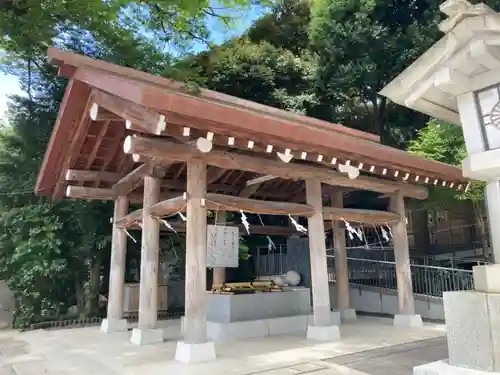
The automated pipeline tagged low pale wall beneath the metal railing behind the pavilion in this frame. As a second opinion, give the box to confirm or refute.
[330,283,444,320]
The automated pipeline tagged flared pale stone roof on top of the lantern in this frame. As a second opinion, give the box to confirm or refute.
[380,0,500,125]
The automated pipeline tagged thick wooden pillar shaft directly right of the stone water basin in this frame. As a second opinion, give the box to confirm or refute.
[306,180,332,327]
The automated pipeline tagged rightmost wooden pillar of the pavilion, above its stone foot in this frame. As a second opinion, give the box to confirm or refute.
[390,191,415,315]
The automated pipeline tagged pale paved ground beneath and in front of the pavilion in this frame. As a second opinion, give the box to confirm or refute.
[0,317,446,375]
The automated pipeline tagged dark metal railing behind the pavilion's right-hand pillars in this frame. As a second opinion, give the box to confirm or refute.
[328,255,474,297]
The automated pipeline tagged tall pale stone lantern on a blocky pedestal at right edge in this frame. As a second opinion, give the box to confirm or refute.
[380,0,500,375]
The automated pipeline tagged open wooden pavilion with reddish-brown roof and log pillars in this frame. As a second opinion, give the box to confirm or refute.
[35,49,468,363]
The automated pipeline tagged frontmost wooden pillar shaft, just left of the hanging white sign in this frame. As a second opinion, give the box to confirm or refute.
[184,159,207,344]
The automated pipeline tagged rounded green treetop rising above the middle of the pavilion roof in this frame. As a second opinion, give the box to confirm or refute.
[191,39,316,113]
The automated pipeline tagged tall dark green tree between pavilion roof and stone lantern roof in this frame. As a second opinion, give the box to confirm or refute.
[310,0,500,148]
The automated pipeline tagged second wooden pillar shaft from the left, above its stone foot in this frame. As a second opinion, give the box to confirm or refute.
[138,176,160,330]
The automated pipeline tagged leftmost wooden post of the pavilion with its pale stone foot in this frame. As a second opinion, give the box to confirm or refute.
[101,196,129,333]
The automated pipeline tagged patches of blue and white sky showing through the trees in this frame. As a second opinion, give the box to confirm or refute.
[0,7,266,119]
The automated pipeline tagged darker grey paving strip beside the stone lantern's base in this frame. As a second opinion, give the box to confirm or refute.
[325,337,448,375]
